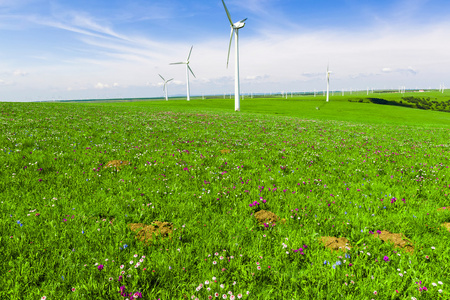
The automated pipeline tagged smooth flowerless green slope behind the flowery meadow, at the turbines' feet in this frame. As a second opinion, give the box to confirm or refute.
[80,93,450,127]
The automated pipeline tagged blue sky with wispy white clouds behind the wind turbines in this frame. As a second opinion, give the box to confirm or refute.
[0,0,450,101]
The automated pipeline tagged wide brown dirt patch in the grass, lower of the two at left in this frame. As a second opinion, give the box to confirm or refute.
[128,220,173,245]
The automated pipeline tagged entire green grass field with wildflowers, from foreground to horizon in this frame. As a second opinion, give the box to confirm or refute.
[0,97,450,299]
